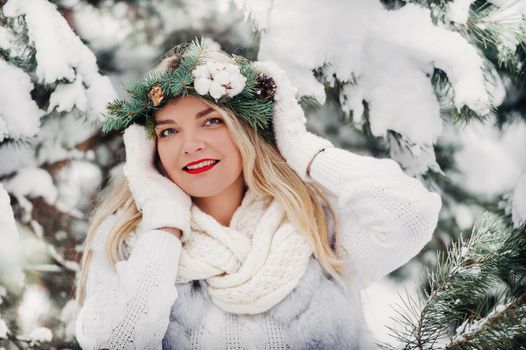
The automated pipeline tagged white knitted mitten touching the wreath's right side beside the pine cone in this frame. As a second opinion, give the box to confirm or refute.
[254,61,334,181]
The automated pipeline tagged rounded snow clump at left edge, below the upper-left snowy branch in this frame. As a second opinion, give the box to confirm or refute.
[0,59,44,139]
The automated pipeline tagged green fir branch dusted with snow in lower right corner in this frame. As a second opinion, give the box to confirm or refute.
[383,214,526,349]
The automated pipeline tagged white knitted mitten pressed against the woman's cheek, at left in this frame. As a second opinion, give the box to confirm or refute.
[123,124,192,241]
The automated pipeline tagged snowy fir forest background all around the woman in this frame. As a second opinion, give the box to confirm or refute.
[0,0,526,349]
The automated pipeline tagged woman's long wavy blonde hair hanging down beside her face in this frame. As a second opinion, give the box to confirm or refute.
[76,48,348,303]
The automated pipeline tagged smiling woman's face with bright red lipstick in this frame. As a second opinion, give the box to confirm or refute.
[155,96,244,197]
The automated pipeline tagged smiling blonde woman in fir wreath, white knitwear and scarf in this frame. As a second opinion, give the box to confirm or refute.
[76,43,441,349]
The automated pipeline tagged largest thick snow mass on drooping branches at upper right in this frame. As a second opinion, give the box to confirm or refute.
[236,0,503,174]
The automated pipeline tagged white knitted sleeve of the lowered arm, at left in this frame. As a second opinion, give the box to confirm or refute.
[76,215,181,350]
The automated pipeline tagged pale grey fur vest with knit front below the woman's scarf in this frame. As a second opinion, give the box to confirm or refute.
[163,258,376,350]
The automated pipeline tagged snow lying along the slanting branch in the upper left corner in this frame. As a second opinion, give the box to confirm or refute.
[4,0,116,124]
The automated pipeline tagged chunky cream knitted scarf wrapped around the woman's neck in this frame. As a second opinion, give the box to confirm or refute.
[177,189,313,314]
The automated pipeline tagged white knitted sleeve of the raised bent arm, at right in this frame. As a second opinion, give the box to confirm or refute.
[310,148,442,288]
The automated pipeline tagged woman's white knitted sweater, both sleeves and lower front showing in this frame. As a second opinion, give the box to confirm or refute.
[76,148,441,350]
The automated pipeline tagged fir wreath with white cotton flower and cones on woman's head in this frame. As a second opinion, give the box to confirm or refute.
[102,39,276,143]
